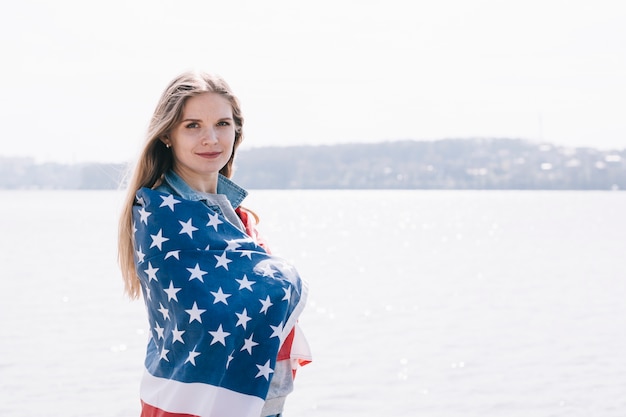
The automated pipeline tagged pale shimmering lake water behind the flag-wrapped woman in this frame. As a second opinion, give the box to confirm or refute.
[0,191,626,417]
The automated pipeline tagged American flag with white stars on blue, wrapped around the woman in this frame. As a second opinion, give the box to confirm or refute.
[133,188,306,417]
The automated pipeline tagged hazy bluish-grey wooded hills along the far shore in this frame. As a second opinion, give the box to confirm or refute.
[0,139,626,190]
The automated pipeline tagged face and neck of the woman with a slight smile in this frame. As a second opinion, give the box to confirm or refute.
[164,93,235,193]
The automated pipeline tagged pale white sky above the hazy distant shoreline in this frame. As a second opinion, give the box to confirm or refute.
[0,0,626,162]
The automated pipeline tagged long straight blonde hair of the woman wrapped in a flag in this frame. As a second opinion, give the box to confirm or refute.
[118,71,243,299]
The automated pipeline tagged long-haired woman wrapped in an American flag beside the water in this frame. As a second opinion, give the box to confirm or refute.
[119,72,310,417]
